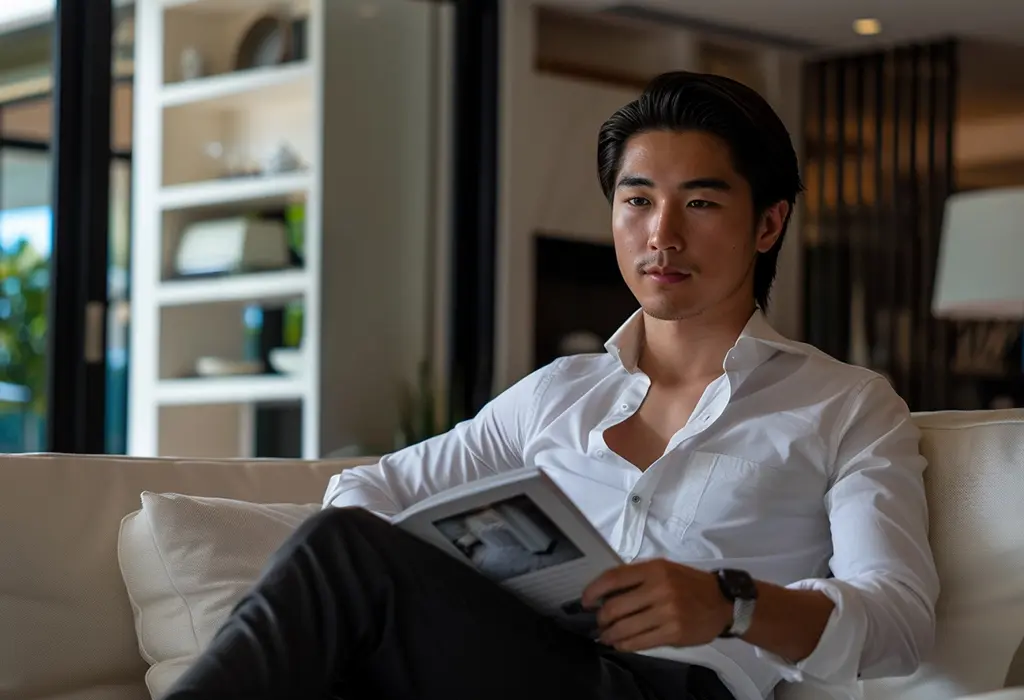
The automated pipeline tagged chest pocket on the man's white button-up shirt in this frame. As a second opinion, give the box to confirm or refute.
[660,452,788,539]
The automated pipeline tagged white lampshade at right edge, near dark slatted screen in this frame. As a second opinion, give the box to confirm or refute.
[932,187,1024,320]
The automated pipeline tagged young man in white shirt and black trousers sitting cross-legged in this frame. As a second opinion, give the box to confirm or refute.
[161,73,938,700]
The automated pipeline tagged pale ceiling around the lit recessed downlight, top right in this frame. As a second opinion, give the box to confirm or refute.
[560,0,1024,49]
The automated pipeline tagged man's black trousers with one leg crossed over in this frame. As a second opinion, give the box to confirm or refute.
[161,509,733,700]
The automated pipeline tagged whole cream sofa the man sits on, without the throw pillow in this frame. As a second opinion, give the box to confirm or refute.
[0,410,1024,700]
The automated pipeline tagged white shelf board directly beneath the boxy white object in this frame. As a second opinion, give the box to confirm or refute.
[157,269,309,306]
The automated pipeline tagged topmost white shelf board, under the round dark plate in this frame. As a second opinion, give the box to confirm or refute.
[161,61,313,111]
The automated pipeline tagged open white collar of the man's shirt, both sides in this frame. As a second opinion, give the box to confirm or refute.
[604,309,811,374]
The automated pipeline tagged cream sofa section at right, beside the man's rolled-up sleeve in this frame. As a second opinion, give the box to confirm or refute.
[864,410,1024,700]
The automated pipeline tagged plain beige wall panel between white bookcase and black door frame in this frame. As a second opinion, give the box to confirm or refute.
[319,0,453,453]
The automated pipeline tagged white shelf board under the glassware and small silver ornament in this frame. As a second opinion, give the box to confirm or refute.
[160,172,312,211]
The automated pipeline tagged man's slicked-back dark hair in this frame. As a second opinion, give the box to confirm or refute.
[597,71,804,311]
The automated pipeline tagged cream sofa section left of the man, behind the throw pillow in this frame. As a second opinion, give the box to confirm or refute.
[0,454,372,700]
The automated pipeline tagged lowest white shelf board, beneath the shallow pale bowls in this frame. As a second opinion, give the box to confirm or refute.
[151,375,304,406]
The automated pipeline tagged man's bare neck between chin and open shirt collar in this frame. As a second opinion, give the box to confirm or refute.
[640,305,754,386]
